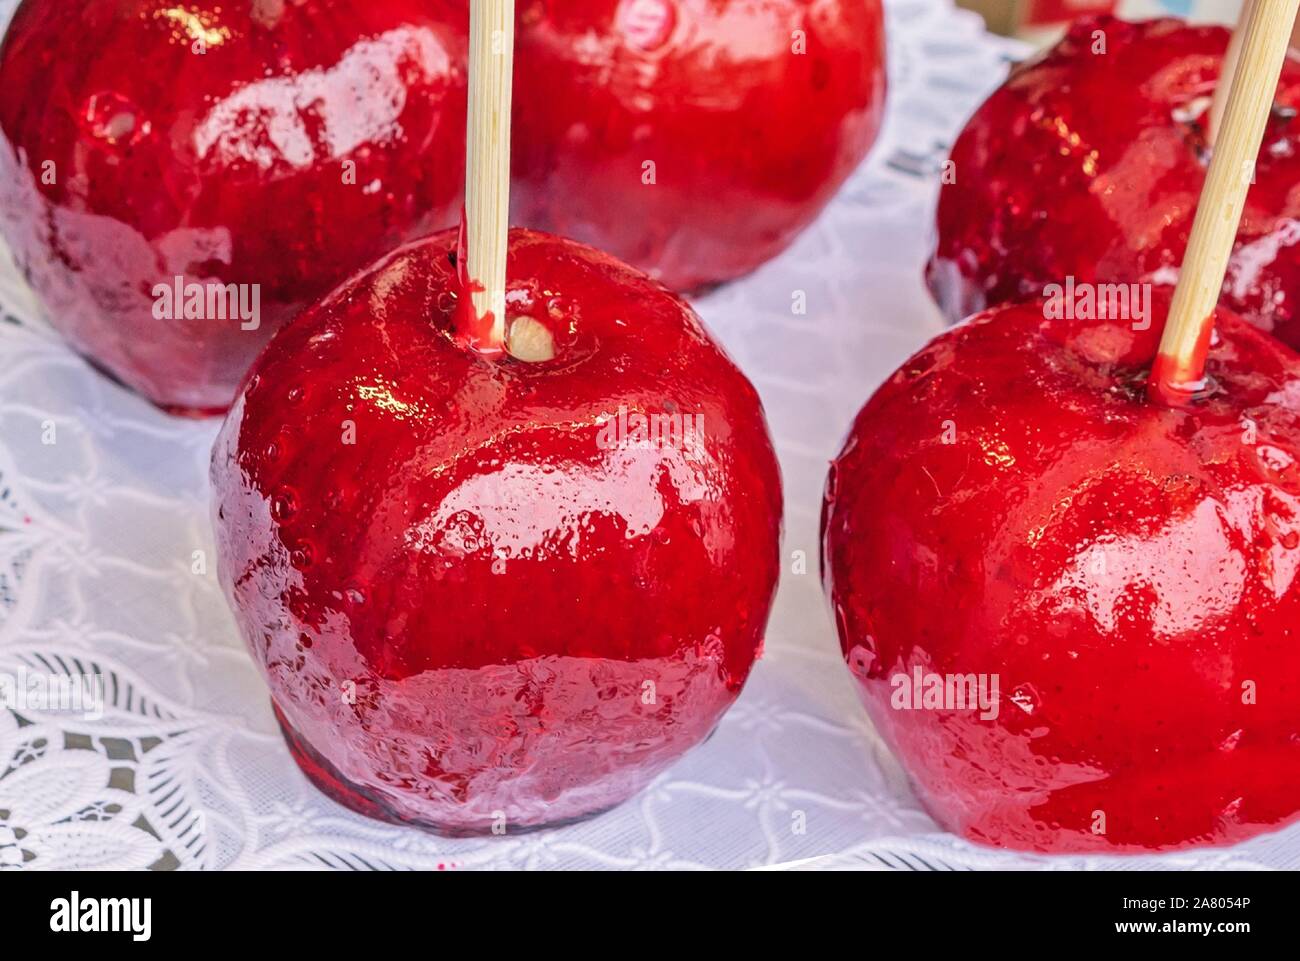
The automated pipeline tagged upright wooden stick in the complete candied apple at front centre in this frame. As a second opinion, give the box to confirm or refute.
[462,0,512,352]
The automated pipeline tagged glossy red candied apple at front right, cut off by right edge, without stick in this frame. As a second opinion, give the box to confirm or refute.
[823,298,1300,853]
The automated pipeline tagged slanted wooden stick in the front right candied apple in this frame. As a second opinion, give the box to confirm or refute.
[1151,0,1300,403]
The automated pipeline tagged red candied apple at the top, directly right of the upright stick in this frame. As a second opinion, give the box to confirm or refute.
[514,0,885,290]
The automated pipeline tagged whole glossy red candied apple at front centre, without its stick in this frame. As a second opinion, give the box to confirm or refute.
[212,230,781,834]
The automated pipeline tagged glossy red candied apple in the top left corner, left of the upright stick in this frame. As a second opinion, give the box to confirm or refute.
[0,0,468,412]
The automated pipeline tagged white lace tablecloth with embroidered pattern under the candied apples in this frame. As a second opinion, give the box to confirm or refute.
[0,0,1300,870]
